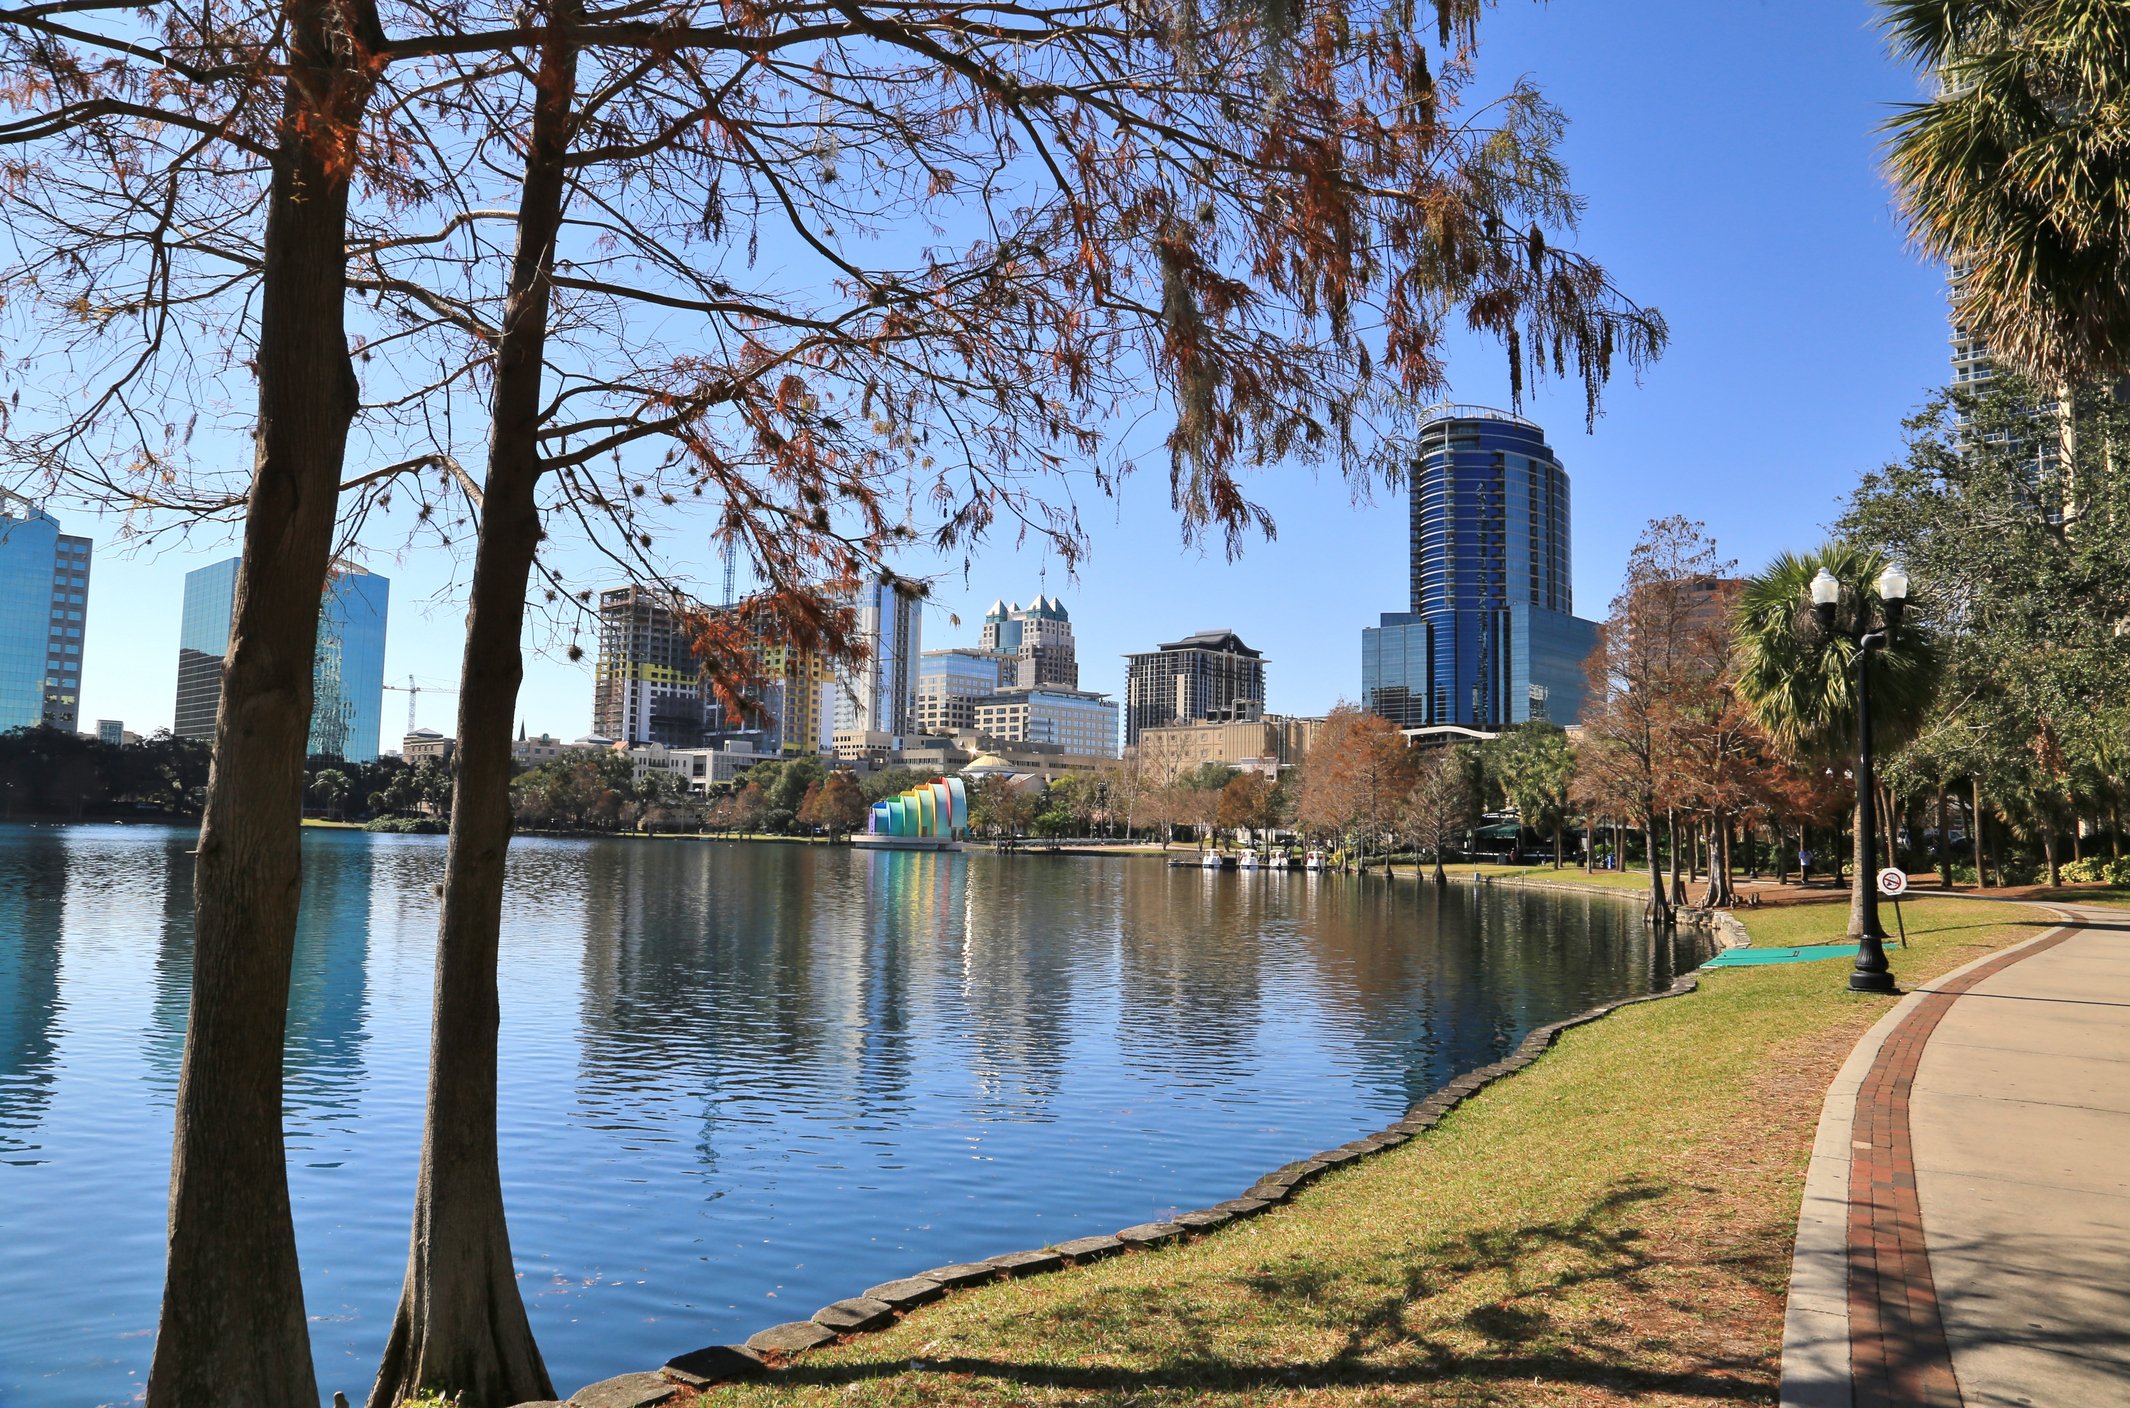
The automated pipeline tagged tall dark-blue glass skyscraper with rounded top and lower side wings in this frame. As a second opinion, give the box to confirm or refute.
[1361,405,1598,728]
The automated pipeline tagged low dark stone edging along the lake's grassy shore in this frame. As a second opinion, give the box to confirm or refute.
[518,915,1751,1408]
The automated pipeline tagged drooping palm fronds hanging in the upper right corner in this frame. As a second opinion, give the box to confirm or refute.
[1879,0,2130,389]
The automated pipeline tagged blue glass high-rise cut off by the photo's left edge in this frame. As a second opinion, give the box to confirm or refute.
[0,490,89,733]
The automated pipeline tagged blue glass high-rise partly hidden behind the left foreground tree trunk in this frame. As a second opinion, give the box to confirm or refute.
[170,558,392,763]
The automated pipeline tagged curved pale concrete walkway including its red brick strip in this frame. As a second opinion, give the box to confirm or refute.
[1783,910,2130,1408]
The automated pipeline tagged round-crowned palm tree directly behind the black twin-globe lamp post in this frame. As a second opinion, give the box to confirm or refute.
[1736,543,1938,935]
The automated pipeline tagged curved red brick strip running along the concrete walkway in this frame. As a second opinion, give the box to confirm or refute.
[1849,927,2077,1408]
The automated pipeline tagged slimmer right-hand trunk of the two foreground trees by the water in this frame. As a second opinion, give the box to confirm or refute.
[371,4,577,1408]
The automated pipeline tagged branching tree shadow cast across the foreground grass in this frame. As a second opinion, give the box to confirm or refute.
[780,1178,1787,1402]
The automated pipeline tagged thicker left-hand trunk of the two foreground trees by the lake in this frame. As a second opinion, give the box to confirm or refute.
[147,0,383,1408]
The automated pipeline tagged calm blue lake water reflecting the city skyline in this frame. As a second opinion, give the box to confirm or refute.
[0,824,1700,1408]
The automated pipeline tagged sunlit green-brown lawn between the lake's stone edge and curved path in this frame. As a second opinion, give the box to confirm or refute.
[675,894,2047,1408]
